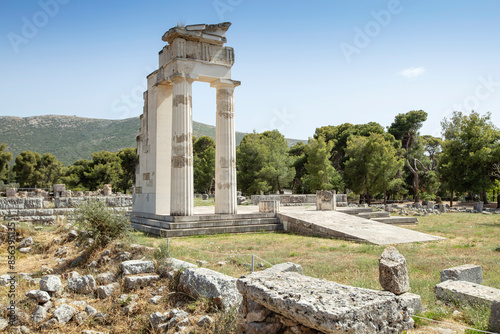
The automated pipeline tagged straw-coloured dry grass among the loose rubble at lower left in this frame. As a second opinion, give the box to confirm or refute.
[0,220,230,334]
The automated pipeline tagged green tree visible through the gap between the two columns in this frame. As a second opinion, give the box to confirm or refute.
[193,136,215,194]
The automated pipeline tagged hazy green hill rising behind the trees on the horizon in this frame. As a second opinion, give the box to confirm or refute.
[0,115,300,165]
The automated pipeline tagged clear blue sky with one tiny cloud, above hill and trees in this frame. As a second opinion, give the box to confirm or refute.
[0,0,500,139]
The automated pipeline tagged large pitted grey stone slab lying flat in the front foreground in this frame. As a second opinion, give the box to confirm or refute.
[237,272,413,333]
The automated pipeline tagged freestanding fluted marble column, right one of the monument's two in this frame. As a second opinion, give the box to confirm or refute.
[211,79,240,214]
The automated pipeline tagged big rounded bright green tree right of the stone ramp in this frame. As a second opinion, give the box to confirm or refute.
[344,133,404,203]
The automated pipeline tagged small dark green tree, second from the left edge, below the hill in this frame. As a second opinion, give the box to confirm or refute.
[12,151,42,188]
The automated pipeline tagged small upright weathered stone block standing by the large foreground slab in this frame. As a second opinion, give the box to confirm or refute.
[379,246,410,295]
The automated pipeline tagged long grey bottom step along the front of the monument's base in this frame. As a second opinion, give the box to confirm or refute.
[130,223,283,237]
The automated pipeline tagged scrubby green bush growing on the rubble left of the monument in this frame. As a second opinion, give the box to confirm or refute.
[75,201,130,248]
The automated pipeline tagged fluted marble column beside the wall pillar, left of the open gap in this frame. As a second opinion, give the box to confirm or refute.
[170,76,194,216]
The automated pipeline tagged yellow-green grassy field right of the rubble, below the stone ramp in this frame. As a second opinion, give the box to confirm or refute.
[132,213,500,333]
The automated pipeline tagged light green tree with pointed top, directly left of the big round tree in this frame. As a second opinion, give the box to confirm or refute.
[304,137,343,193]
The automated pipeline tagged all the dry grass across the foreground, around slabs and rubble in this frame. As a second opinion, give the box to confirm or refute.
[0,213,500,333]
